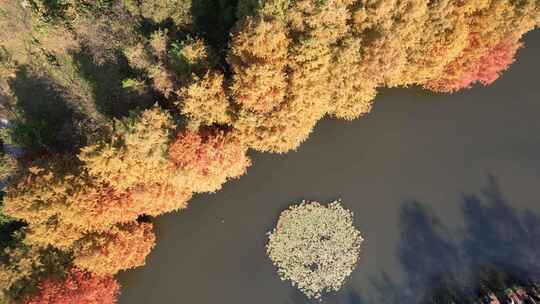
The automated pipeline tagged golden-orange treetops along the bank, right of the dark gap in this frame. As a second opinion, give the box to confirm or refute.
[227,0,540,153]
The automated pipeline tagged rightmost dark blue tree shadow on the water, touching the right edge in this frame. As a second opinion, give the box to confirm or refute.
[463,176,540,284]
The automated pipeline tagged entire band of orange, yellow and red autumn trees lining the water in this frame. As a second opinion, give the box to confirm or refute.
[0,0,540,303]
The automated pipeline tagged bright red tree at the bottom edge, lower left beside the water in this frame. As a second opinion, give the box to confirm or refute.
[24,268,120,304]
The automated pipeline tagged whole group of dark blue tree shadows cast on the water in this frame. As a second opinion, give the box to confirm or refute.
[372,175,540,303]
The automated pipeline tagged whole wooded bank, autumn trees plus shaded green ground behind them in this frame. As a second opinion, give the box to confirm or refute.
[0,0,540,303]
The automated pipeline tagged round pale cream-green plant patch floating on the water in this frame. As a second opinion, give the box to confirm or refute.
[266,201,363,299]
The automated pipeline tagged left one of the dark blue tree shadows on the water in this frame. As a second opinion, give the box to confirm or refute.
[398,201,471,303]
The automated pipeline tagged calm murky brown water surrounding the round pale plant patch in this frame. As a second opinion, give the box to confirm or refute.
[120,31,540,304]
